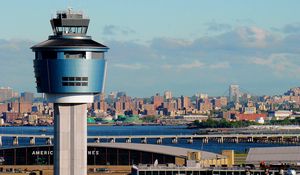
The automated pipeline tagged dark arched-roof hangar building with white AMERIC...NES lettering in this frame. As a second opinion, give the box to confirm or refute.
[0,143,227,166]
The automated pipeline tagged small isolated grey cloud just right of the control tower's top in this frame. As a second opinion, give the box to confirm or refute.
[102,25,136,36]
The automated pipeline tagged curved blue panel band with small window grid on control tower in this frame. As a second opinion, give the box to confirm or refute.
[34,59,105,93]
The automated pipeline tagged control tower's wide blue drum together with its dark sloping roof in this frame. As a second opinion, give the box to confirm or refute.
[32,36,108,94]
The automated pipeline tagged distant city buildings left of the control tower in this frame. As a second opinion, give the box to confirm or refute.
[0,87,53,125]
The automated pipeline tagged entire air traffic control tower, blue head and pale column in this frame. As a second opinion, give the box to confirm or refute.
[31,9,108,175]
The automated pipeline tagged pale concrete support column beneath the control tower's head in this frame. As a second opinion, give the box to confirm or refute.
[53,103,87,175]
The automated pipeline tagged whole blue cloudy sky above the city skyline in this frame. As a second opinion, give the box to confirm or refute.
[0,0,300,97]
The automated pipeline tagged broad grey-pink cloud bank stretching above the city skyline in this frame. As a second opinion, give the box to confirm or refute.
[0,24,300,97]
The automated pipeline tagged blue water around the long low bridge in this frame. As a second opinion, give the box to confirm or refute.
[0,126,294,153]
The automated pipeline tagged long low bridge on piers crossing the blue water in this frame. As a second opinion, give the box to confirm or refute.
[0,134,300,146]
